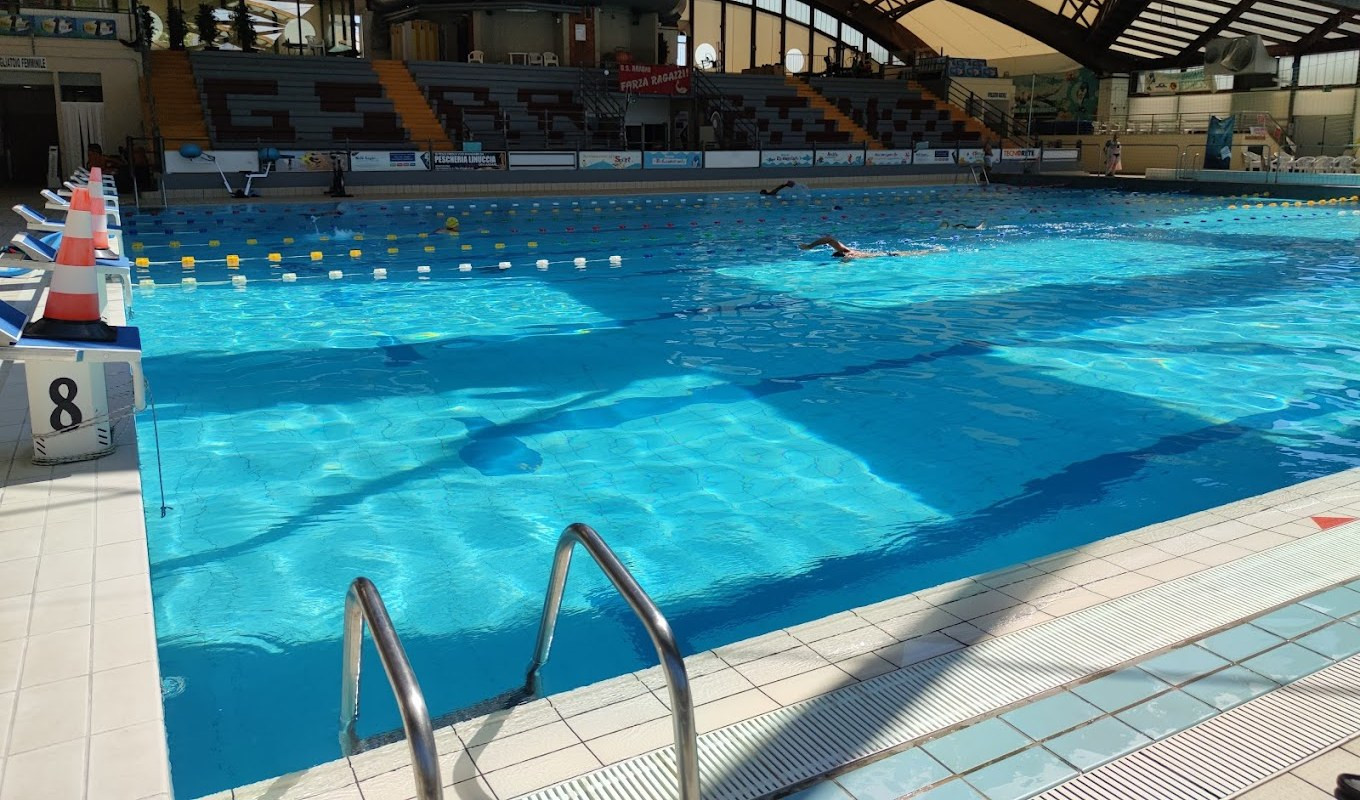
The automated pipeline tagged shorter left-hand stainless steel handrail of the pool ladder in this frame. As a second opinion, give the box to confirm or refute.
[340,578,443,800]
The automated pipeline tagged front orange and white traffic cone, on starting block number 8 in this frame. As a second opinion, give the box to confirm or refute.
[24,188,118,341]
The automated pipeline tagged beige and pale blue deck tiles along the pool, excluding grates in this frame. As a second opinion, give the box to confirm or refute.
[0,200,1360,800]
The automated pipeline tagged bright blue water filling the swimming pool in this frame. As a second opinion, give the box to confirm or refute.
[128,188,1360,797]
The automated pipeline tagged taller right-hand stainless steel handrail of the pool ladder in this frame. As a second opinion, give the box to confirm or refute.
[525,522,699,800]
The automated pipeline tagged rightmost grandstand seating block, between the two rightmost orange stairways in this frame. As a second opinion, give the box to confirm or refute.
[809,78,981,147]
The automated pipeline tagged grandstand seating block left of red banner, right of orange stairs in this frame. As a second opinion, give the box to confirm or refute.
[407,61,595,150]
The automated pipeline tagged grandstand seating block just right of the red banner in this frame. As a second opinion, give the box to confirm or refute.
[709,73,850,148]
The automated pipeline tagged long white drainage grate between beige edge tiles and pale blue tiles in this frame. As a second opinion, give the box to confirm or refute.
[524,524,1360,800]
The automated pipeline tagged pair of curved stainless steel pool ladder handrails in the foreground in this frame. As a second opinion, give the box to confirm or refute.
[340,522,699,800]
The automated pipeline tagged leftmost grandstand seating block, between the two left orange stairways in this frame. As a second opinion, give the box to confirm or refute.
[190,50,411,147]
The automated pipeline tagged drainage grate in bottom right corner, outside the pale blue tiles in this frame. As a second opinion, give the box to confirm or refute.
[1035,656,1360,800]
